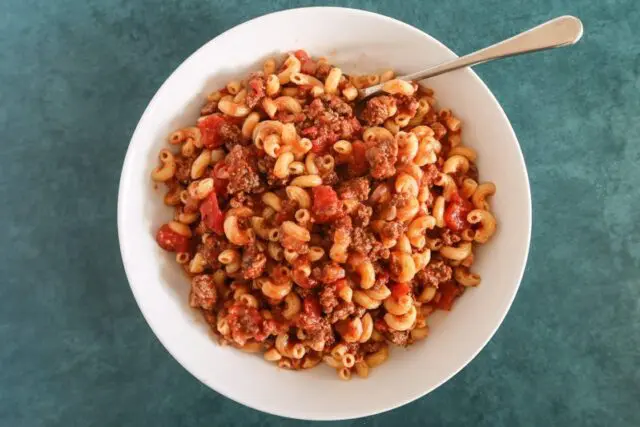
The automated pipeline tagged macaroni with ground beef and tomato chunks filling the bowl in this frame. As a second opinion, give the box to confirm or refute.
[151,50,497,380]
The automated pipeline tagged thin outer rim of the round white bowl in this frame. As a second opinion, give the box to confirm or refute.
[117,6,533,421]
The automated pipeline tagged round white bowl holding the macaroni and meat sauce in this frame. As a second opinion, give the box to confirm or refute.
[118,8,531,420]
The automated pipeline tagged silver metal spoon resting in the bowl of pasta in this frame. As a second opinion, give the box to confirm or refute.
[359,16,582,100]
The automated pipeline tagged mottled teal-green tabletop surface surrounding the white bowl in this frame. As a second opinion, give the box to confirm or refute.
[0,0,640,427]
